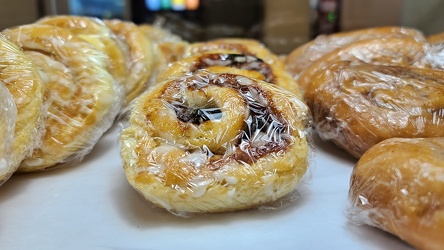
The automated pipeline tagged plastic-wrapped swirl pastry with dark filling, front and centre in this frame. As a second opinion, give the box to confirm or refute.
[120,71,308,213]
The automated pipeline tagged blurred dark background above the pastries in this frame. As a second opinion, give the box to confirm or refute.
[0,0,444,53]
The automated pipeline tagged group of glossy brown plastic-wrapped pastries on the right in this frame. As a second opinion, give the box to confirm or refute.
[285,27,444,249]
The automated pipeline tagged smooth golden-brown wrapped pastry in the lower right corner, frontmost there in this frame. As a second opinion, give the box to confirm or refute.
[349,137,444,249]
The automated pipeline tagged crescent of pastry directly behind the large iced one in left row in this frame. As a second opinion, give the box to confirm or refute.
[104,19,155,104]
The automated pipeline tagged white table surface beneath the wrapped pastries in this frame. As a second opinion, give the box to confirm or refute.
[0,125,411,250]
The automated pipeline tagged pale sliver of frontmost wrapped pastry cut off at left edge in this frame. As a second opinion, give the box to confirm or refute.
[0,81,17,185]
